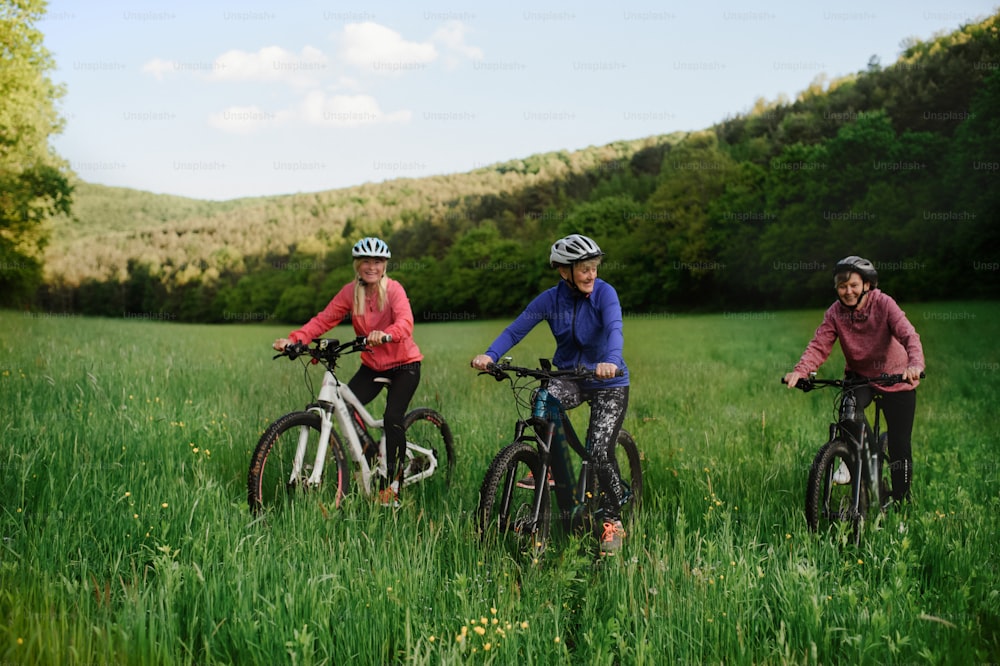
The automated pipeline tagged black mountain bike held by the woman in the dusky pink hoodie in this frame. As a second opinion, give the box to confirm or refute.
[781,373,924,545]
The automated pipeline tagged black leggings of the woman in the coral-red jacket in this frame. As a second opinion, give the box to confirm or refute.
[347,361,420,485]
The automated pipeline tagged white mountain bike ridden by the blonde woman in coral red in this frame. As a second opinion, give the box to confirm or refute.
[247,337,455,515]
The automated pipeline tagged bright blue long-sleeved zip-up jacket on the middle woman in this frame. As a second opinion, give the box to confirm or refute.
[486,278,629,388]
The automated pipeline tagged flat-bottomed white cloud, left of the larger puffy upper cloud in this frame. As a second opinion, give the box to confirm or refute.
[211,46,329,87]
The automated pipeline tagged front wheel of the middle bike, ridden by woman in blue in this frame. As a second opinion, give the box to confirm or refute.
[478,442,552,557]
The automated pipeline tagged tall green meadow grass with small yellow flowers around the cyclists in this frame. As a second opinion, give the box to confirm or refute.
[0,303,1000,664]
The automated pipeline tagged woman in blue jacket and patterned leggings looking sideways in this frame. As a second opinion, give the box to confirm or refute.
[472,234,629,555]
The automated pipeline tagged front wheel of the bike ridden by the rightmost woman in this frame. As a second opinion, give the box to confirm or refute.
[806,439,869,545]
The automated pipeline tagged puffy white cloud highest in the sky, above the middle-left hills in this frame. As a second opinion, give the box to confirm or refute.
[340,21,438,74]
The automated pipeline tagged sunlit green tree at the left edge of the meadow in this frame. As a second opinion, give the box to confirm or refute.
[0,0,72,306]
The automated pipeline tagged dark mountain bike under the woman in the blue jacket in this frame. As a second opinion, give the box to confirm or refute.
[478,359,642,557]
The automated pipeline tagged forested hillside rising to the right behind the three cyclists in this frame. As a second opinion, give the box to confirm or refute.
[37,15,1000,322]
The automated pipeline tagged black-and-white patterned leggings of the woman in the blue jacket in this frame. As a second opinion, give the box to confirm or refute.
[549,379,629,521]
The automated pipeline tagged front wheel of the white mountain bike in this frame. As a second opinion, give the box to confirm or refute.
[247,412,351,515]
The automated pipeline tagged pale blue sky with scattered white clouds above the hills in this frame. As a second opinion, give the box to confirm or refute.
[38,0,998,200]
